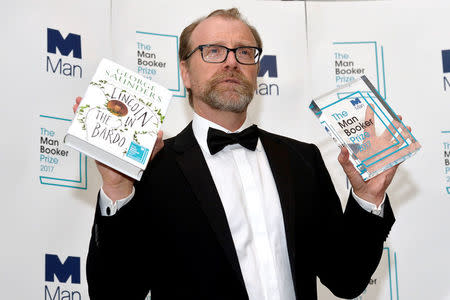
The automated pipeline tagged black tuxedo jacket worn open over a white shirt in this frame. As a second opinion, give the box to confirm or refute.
[87,125,394,300]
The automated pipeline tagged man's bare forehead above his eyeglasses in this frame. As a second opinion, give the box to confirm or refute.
[191,16,256,47]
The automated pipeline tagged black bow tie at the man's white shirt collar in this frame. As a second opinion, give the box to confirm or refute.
[206,125,258,155]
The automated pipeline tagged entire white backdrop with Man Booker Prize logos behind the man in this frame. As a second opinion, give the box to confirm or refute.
[0,0,450,300]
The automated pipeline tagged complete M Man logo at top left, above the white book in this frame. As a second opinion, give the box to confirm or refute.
[46,28,83,78]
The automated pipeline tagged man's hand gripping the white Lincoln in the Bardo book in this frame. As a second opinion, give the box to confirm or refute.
[72,97,164,202]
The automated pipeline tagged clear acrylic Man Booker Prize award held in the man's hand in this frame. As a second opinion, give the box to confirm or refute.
[309,76,421,180]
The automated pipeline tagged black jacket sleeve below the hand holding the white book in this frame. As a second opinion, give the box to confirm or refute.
[86,185,151,300]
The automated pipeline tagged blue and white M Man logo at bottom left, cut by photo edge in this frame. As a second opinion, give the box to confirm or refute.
[44,254,81,300]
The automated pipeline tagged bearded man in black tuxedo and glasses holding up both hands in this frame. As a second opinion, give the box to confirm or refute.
[84,9,396,300]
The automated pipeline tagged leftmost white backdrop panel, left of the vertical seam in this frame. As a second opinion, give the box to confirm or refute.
[0,0,111,299]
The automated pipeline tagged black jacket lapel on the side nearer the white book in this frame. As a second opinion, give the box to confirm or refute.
[174,122,245,288]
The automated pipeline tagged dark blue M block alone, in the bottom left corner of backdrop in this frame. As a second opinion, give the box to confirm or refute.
[45,254,80,283]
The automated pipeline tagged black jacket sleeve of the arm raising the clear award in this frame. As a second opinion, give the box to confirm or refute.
[314,146,395,299]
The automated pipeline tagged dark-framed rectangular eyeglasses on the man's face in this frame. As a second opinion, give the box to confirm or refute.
[186,45,262,65]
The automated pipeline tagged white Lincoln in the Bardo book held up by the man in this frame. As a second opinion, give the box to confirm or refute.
[64,59,172,180]
